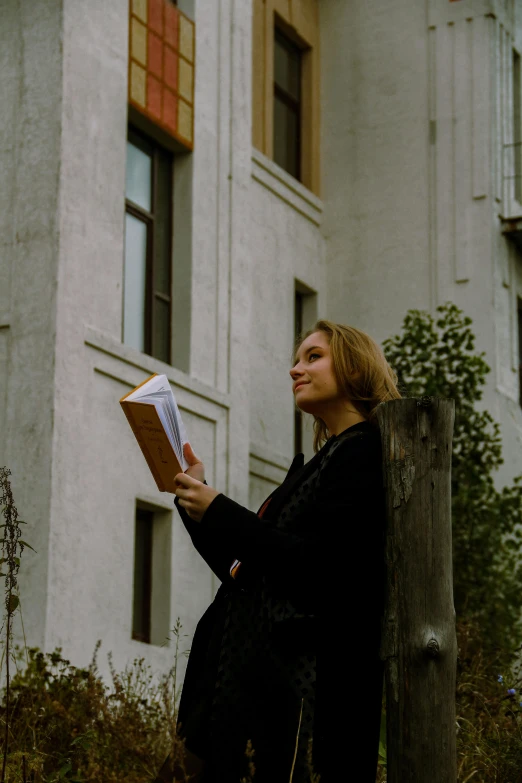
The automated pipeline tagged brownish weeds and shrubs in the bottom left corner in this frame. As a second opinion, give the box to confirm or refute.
[0,636,189,783]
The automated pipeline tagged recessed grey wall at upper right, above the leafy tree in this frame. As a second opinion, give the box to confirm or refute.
[321,0,522,488]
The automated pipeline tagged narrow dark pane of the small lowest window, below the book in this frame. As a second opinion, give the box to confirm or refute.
[132,508,153,642]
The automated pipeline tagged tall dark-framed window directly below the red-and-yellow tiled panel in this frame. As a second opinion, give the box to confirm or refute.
[123,130,173,364]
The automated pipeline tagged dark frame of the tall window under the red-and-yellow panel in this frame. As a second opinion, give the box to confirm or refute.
[122,125,174,364]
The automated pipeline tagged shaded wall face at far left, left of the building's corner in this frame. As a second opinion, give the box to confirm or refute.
[0,0,63,656]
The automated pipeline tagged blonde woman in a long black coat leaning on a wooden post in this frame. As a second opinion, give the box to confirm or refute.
[152,320,400,783]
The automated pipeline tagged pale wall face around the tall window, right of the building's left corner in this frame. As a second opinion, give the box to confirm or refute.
[38,0,251,670]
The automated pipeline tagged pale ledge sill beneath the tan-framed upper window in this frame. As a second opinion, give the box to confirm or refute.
[252,147,323,226]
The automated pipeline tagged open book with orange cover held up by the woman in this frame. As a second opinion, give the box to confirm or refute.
[120,373,189,492]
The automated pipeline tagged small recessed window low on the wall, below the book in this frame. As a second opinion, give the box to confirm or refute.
[132,501,172,645]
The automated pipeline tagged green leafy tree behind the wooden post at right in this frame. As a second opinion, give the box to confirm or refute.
[383,303,522,654]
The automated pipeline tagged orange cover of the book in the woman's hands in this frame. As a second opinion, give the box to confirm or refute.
[120,373,185,493]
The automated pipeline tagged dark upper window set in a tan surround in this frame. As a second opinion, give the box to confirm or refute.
[274,27,301,179]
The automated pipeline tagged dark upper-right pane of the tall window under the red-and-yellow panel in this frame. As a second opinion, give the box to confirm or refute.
[154,151,172,297]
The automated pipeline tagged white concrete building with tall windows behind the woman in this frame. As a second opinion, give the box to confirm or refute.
[0,0,522,670]
